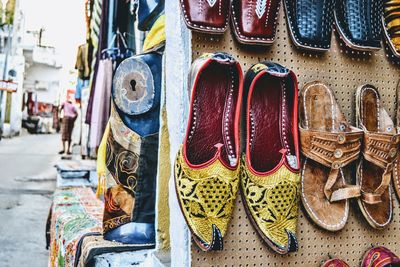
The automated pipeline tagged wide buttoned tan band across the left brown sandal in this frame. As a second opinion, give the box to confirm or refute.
[300,127,363,169]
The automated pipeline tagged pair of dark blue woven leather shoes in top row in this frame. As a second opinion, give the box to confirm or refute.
[283,0,382,51]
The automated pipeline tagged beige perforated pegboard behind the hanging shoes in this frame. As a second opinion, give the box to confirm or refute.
[192,7,400,267]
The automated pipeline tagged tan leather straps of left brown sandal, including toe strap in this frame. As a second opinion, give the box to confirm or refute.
[300,127,363,202]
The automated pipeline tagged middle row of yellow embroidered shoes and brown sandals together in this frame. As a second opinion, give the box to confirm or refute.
[175,53,400,254]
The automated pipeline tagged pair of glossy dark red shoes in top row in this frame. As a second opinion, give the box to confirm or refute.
[181,0,280,45]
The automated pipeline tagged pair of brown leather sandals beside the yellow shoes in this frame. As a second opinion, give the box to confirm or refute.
[299,82,400,231]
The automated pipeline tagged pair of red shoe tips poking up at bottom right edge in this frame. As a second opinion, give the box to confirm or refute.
[321,247,400,267]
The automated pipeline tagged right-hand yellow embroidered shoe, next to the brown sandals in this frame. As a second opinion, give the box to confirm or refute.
[240,62,300,254]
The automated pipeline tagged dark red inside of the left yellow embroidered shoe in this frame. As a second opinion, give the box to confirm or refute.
[186,62,238,166]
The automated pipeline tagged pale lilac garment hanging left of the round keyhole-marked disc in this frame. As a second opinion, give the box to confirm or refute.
[89,59,113,148]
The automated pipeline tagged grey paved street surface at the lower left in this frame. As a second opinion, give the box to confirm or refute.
[0,134,60,267]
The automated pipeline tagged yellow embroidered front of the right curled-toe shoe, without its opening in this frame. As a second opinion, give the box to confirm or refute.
[241,159,300,254]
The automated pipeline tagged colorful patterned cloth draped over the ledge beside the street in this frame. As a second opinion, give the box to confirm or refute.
[48,188,104,267]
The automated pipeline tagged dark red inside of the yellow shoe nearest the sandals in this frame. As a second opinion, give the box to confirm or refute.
[252,75,295,172]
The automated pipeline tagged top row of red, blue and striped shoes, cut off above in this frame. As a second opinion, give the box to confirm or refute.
[180,0,400,58]
